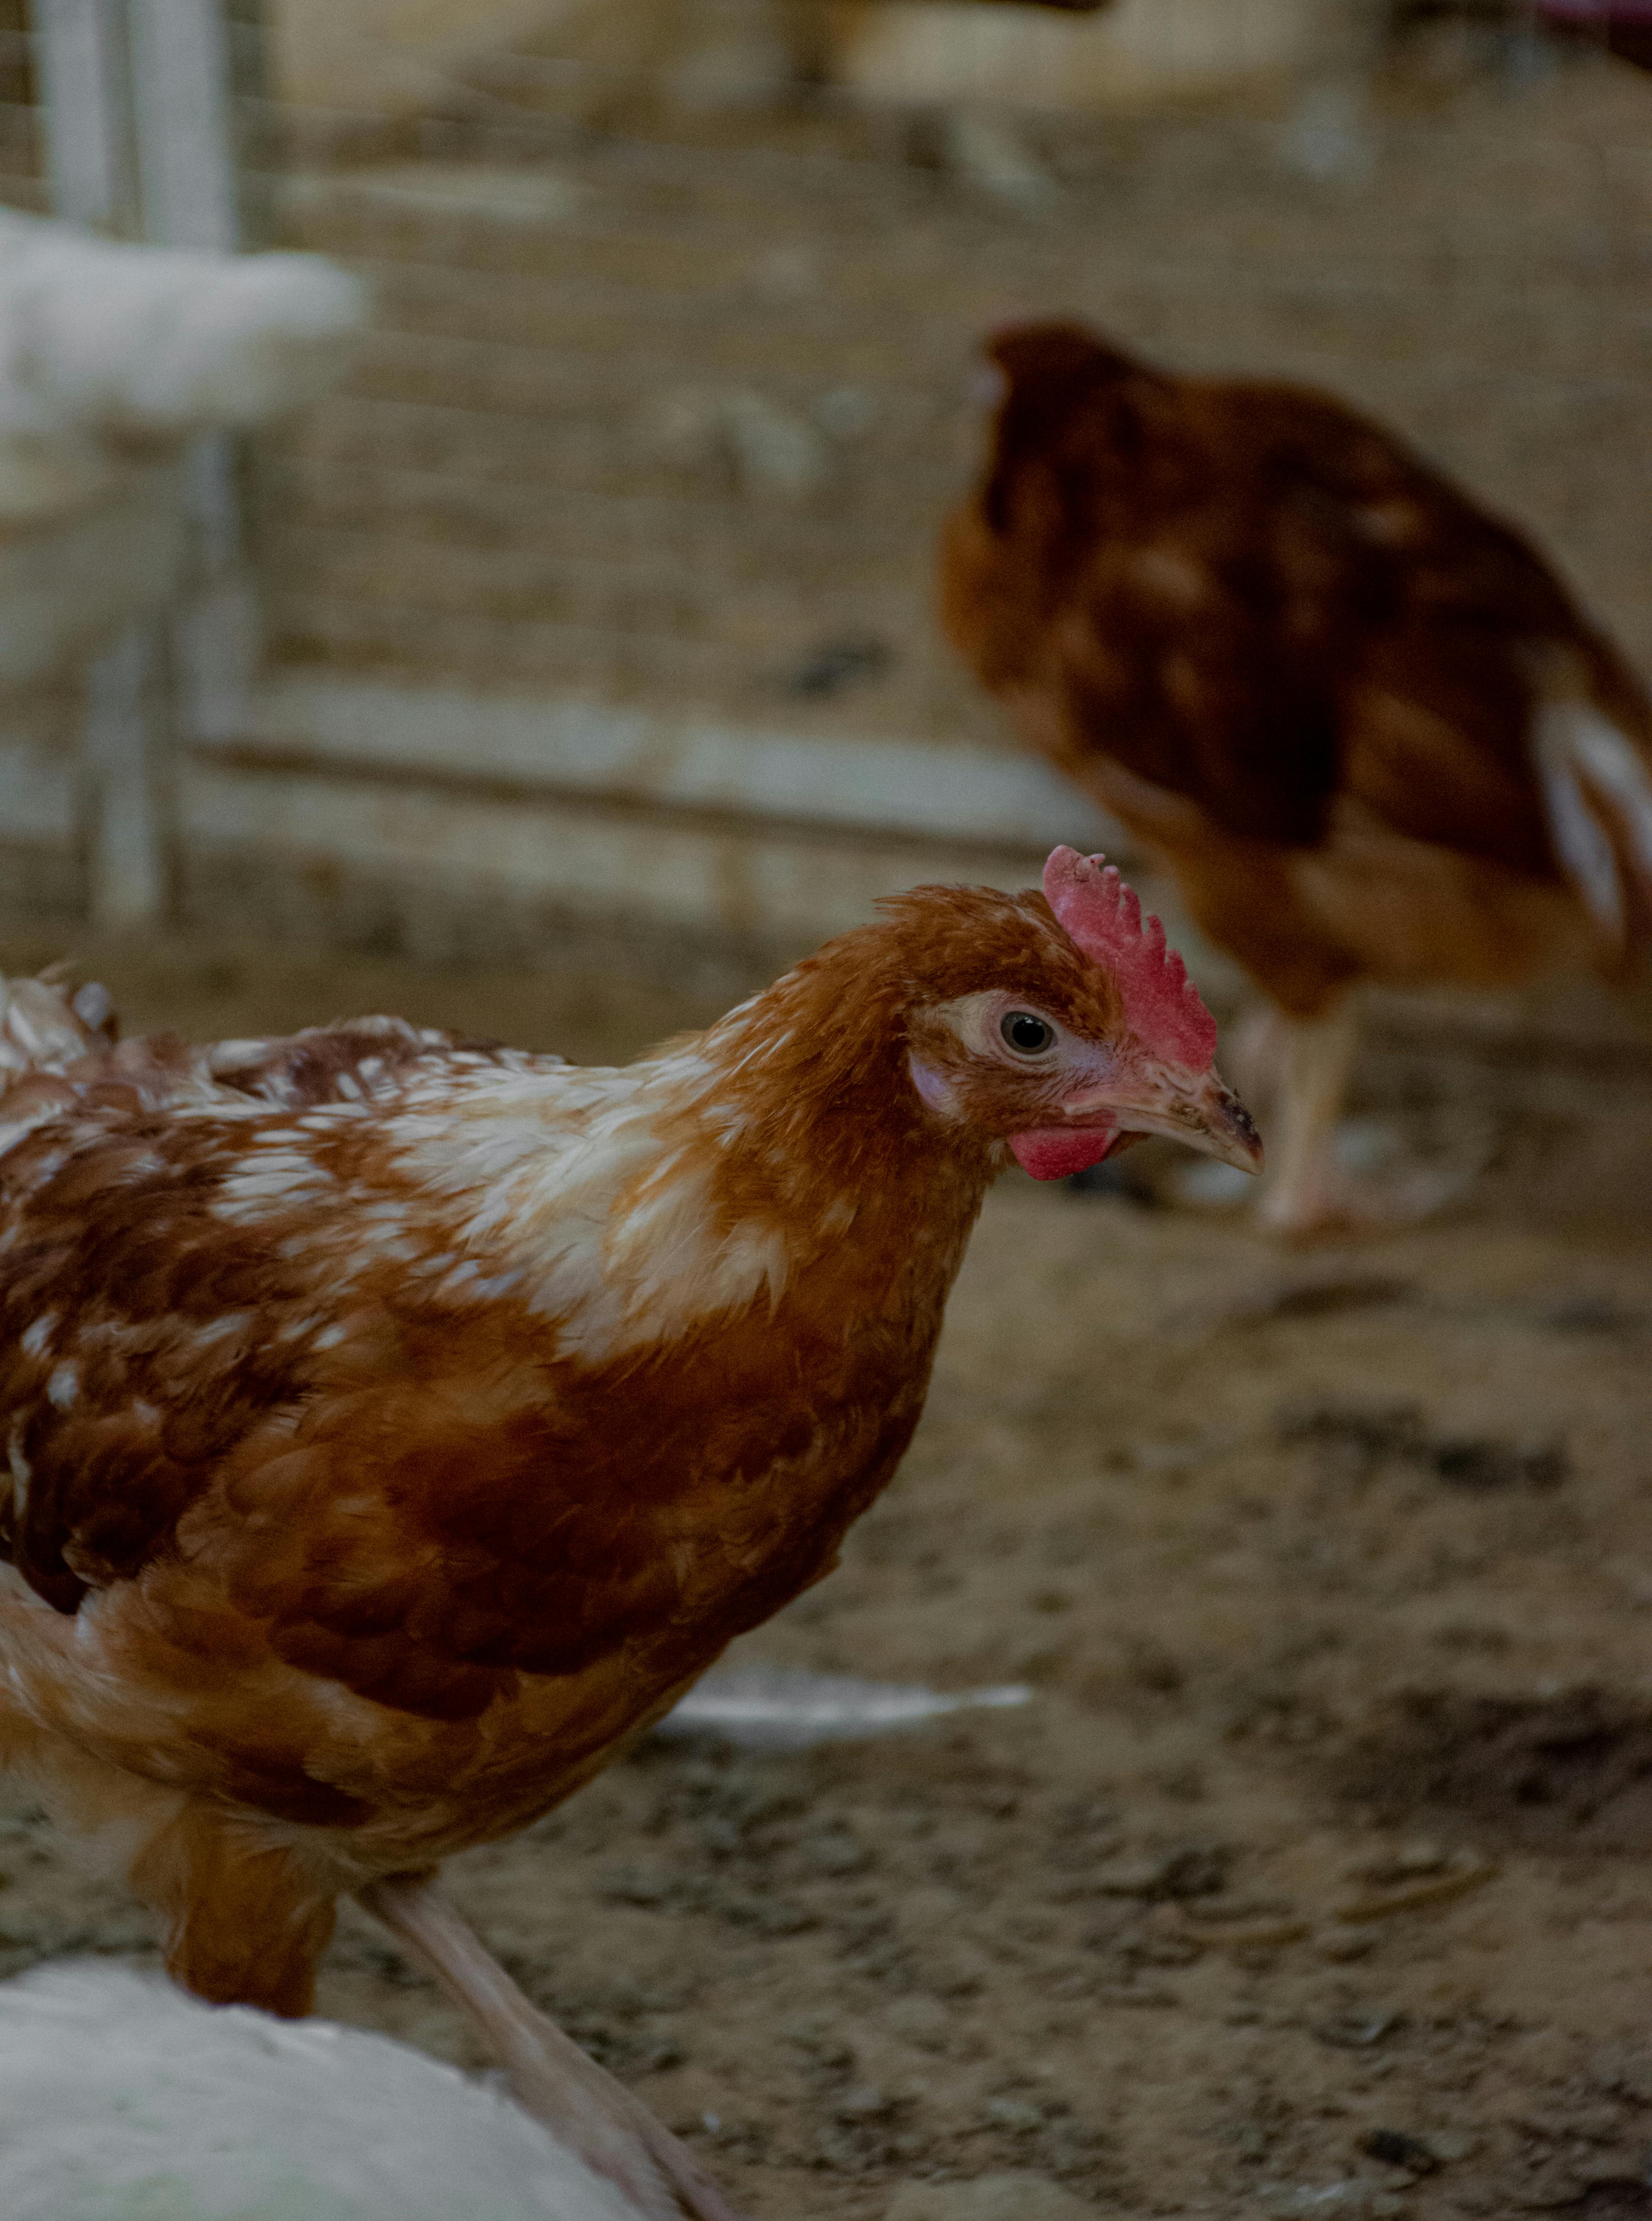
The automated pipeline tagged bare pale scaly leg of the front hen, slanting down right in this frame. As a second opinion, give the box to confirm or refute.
[360,1875,739,2221]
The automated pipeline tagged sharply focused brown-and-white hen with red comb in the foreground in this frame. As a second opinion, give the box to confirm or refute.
[0,851,1257,2221]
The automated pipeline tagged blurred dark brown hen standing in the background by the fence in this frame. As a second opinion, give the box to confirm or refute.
[942,324,1652,1230]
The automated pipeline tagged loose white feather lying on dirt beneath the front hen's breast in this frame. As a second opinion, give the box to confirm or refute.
[655,1666,1032,1750]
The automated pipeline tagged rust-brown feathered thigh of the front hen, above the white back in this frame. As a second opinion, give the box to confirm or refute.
[126,1803,335,2021]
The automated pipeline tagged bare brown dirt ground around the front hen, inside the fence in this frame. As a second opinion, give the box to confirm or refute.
[0,928,1652,2221]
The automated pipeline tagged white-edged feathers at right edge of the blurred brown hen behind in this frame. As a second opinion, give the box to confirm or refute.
[1532,700,1652,955]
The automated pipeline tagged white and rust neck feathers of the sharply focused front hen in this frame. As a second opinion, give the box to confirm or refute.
[389,926,995,1362]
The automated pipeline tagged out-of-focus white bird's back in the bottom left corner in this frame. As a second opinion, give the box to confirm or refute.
[0,1961,639,2221]
